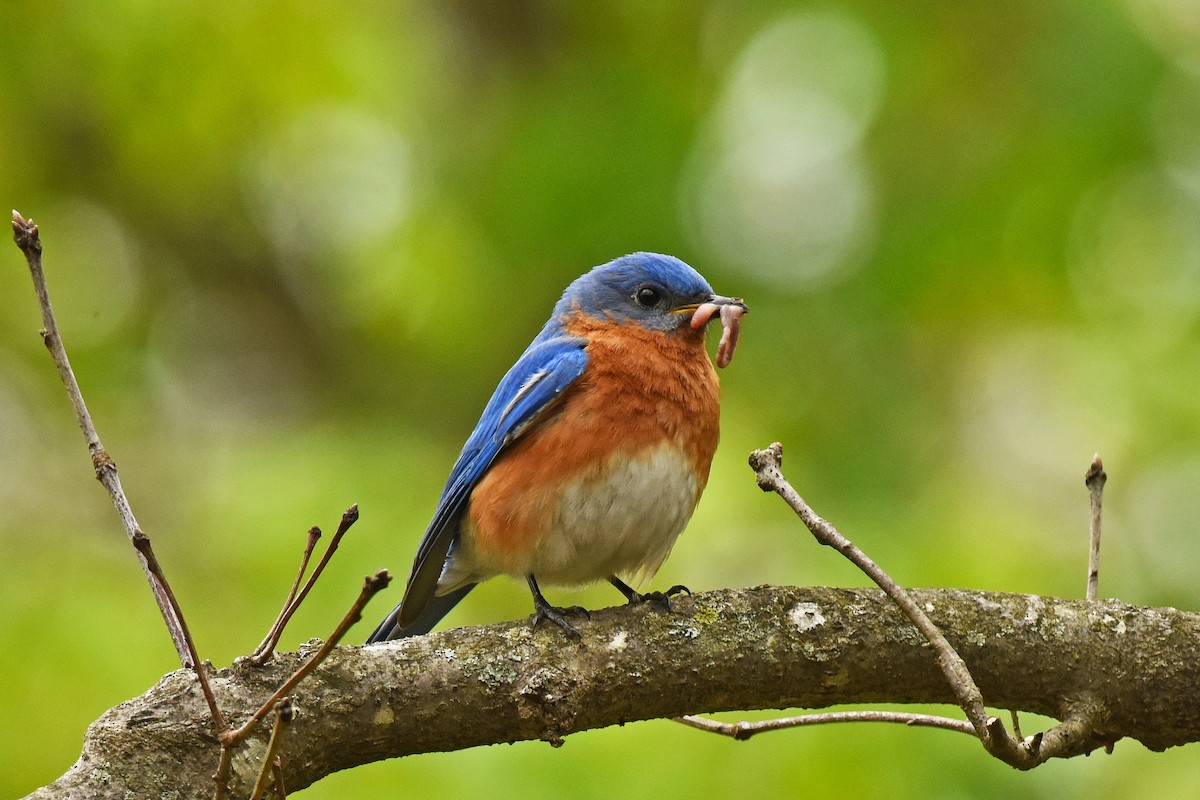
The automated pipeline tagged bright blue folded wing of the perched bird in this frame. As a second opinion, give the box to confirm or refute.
[398,336,588,626]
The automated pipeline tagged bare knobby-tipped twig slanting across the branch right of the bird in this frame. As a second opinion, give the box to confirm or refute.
[750,441,1102,770]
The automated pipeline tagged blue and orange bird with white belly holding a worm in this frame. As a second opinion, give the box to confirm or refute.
[367,252,748,644]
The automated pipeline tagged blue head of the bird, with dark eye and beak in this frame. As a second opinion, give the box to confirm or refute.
[552,253,742,331]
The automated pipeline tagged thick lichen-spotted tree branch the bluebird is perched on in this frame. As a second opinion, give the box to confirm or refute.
[21,588,1200,799]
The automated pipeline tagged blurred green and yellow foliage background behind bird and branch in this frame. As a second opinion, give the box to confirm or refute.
[0,0,1200,800]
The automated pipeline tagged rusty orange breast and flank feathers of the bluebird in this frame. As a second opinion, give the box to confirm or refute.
[464,315,720,579]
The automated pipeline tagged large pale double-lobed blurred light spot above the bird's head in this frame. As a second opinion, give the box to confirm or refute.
[683,12,886,288]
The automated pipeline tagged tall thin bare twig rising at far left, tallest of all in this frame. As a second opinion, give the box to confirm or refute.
[12,211,224,732]
